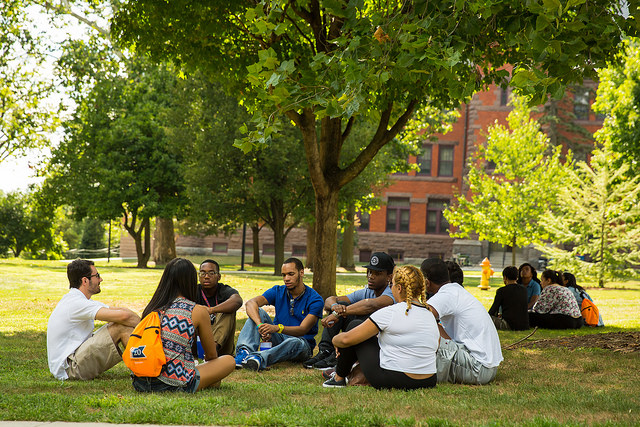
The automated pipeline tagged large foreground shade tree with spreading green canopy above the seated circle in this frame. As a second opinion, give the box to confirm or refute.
[112,0,638,297]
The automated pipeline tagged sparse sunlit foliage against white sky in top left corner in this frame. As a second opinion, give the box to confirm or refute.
[0,0,57,163]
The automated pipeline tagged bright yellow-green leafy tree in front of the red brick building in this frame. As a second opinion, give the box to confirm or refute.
[444,98,566,265]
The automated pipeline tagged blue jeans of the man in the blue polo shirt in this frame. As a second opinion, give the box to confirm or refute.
[236,309,312,367]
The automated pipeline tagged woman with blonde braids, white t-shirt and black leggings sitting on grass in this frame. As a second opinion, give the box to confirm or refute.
[323,265,440,389]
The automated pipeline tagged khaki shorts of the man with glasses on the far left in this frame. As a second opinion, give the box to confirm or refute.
[66,325,122,380]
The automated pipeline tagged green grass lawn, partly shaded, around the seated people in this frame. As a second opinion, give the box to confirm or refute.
[0,258,640,426]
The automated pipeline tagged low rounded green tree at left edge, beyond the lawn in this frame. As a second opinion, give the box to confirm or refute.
[0,192,64,258]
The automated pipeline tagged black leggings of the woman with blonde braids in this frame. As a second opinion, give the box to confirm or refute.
[336,319,437,390]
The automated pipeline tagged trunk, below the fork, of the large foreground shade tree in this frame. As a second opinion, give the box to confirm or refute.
[313,189,339,299]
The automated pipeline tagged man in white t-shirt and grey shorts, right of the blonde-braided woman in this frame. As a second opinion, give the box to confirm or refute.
[422,260,503,384]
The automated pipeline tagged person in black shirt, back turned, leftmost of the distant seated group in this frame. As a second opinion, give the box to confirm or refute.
[489,266,529,331]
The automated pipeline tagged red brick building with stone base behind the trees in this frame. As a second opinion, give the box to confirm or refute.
[121,81,602,266]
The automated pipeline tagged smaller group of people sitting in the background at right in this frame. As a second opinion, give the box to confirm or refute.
[489,263,604,331]
